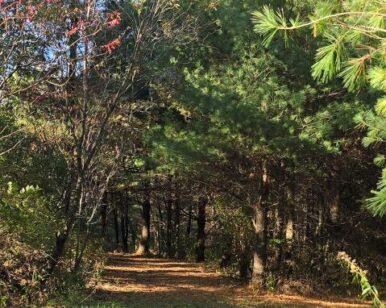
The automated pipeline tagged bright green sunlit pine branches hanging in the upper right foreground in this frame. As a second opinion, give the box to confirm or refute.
[253,0,386,216]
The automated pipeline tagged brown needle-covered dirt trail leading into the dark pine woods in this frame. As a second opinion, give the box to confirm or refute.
[89,254,368,307]
